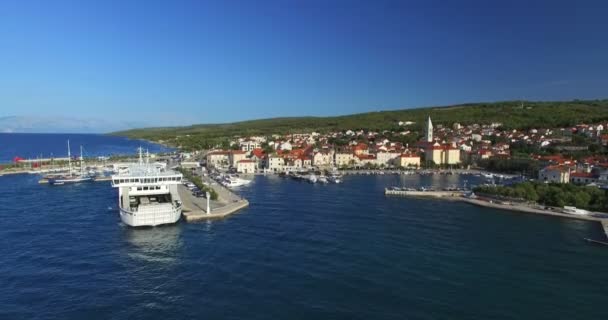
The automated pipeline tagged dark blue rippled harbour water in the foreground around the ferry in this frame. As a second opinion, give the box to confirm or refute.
[0,169,608,319]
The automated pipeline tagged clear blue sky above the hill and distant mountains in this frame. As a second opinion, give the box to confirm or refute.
[0,0,608,125]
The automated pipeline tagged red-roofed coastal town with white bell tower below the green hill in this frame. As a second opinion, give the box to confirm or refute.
[182,117,608,186]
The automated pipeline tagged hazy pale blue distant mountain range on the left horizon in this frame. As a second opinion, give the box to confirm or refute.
[0,116,146,133]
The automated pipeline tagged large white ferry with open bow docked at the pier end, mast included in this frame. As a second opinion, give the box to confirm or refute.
[112,149,183,227]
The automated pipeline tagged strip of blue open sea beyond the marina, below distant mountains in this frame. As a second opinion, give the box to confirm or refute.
[0,133,171,163]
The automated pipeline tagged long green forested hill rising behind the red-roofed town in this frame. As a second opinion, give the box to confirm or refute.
[113,99,608,142]
